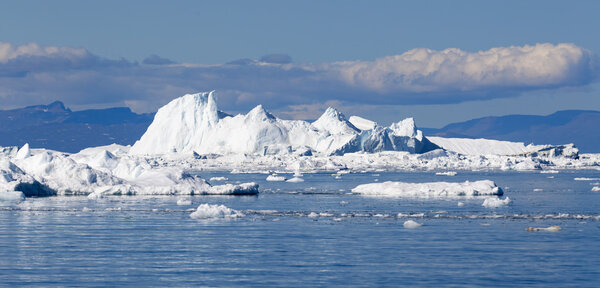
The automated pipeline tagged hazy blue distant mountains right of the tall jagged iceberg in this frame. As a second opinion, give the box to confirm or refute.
[422,110,600,153]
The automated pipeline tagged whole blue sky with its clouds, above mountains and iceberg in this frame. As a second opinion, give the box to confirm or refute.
[0,1,600,127]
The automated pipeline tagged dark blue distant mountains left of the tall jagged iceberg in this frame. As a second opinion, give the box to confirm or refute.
[0,101,154,152]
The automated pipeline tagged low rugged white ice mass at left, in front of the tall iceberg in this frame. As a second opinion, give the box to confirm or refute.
[0,145,258,198]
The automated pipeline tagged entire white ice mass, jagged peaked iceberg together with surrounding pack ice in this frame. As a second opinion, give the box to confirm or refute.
[0,91,600,199]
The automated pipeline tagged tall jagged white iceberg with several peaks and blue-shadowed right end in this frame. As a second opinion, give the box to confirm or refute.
[130,91,439,155]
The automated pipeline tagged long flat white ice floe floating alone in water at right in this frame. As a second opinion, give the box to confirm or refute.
[352,180,503,198]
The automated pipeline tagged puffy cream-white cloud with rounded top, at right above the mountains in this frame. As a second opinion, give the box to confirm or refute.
[327,44,595,93]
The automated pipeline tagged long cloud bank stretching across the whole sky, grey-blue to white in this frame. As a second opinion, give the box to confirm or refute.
[0,42,597,117]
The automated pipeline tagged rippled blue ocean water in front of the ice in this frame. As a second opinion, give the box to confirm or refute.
[0,171,600,287]
